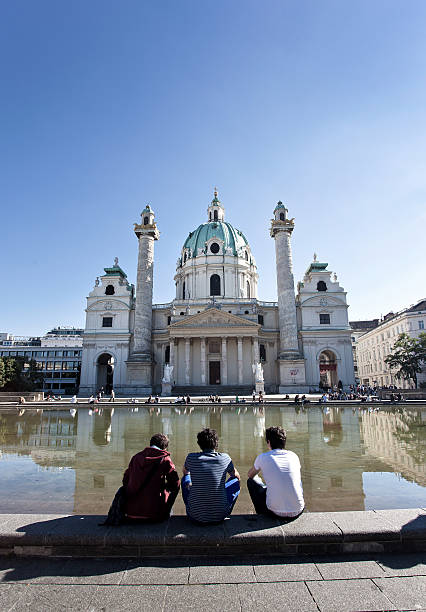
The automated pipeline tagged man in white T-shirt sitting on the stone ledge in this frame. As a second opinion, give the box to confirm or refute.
[247,427,305,518]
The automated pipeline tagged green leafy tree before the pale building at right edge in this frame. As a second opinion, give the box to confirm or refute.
[385,332,426,388]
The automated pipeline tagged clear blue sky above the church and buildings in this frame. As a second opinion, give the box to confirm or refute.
[0,0,426,334]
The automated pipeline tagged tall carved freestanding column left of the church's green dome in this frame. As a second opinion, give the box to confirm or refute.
[126,205,160,394]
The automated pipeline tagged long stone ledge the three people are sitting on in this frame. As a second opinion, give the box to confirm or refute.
[0,508,426,557]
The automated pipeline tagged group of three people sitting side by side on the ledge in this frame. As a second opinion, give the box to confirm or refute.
[118,427,305,524]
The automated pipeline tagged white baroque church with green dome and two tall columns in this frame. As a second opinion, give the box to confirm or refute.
[80,190,355,397]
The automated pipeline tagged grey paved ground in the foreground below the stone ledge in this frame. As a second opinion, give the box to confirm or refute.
[0,553,426,612]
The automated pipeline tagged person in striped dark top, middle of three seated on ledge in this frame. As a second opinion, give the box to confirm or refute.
[182,428,240,524]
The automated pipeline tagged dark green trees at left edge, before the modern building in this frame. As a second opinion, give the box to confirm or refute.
[0,357,43,391]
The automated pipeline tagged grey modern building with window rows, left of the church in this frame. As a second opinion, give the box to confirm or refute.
[0,327,83,395]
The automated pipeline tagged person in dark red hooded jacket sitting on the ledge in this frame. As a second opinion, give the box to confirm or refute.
[123,433,180,521]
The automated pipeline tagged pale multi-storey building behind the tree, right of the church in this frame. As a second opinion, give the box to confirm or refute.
[356,299,426,389]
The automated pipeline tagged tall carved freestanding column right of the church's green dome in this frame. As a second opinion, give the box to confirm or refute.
[271,202,305,392]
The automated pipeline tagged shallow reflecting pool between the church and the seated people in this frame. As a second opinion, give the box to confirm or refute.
[0,404,426,514]
